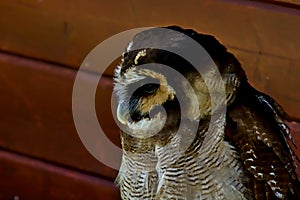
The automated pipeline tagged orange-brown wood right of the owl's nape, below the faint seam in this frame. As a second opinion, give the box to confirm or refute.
[230,49,300,119]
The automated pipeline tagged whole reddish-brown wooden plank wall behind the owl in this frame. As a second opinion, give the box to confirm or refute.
[0,0,300,200]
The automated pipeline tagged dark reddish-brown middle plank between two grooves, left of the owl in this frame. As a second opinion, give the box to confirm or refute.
[0,54,120,180]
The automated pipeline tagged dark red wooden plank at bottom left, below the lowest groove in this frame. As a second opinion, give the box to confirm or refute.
[0,150,120,200]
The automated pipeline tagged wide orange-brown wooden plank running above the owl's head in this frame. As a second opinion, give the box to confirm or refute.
[0,0,300,72]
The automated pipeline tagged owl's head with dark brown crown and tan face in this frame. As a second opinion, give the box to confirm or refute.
[114,26,243,149]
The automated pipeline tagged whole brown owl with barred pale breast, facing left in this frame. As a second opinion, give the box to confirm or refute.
[114,26,300,200]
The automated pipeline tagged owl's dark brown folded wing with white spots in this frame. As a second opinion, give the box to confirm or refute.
[225,81,300,199]
